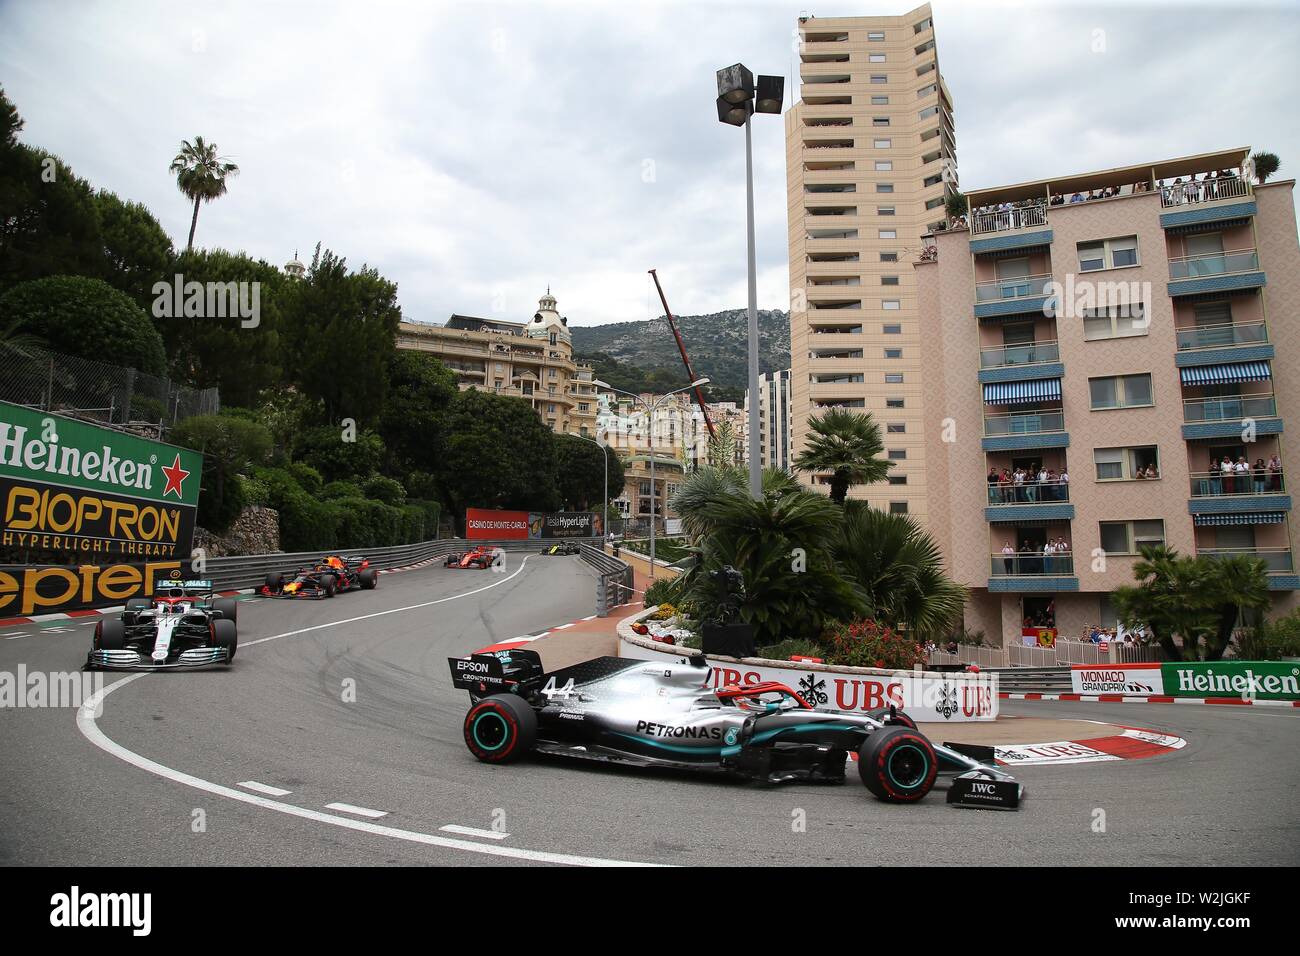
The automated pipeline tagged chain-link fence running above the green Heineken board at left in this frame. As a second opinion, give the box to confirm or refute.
[0,342,221,438]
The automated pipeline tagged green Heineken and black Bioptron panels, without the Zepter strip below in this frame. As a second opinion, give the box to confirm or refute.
[0,402,203,564]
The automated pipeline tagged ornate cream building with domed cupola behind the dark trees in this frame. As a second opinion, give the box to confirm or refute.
[397,289,598,437]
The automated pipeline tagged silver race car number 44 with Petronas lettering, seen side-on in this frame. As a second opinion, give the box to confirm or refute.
[449,649,1024,810]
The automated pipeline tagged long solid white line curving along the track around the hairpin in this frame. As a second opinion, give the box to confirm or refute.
[77,558,657,866]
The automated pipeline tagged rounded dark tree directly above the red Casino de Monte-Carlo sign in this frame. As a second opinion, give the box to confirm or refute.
[438,389,559,527]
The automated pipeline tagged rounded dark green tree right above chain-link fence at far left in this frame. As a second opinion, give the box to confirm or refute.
[0,276,166,375]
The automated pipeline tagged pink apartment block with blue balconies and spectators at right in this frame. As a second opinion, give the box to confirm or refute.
[917,148,1300,637]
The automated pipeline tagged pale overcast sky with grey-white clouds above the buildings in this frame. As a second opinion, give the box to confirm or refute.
[0,0,1300,325]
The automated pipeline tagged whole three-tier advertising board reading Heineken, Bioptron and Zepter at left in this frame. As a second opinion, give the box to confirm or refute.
[0,402,203,617]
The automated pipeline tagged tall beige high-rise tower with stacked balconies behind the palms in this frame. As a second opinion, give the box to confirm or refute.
[785,4,957,522]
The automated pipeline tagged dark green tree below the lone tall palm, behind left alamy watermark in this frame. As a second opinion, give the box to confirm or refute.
[165,248,284,407]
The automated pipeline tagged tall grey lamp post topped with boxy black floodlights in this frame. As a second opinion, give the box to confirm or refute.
[718,64,785,501]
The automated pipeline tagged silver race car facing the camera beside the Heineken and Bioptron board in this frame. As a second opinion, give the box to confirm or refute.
[86,580,239,670]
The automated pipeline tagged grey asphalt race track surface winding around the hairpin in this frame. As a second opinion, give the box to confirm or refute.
[0,557,1300,866]
